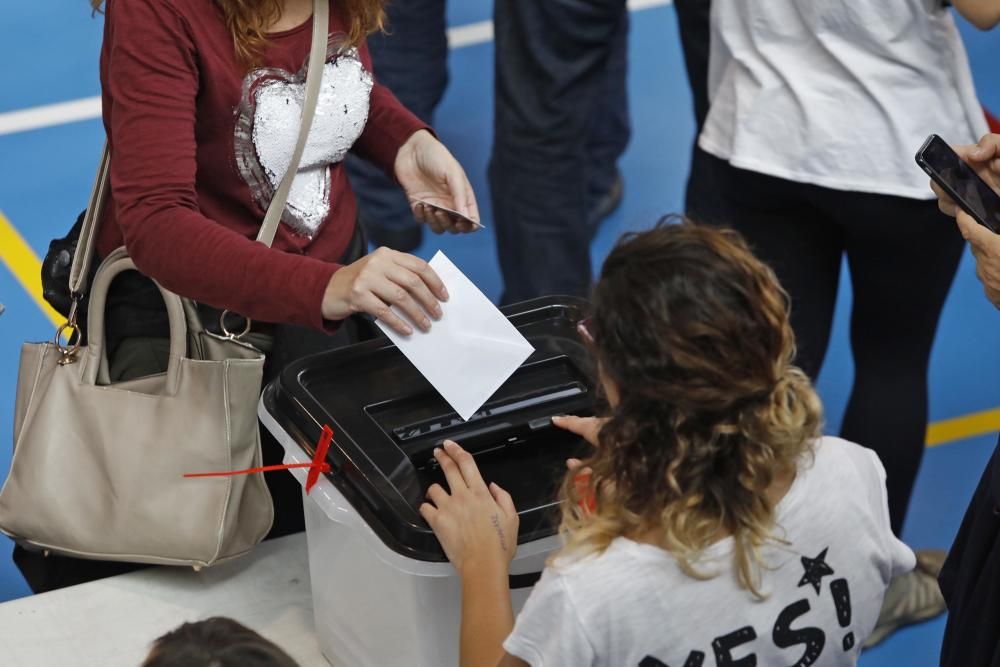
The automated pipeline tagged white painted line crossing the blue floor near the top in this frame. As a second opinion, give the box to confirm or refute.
[0,0,671,136]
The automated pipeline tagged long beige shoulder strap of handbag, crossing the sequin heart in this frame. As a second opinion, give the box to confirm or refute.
[60,0,330,324]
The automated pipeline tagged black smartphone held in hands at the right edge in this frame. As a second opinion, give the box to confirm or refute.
[916,134,1000,234]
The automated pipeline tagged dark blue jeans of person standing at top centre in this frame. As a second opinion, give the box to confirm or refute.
[489,0,630,303]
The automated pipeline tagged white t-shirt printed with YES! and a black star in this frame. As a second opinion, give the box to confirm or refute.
[504,437,915,667]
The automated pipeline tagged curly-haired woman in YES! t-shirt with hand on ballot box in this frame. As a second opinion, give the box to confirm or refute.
[421,223,915,667]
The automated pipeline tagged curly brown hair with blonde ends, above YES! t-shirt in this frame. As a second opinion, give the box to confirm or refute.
[561,219,822,597]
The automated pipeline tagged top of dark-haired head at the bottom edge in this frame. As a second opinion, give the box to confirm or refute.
[142,617,298,667]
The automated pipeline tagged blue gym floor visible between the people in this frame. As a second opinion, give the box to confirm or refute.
[0,0,1000,667]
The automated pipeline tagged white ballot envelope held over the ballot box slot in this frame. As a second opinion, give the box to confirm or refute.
[376,251,535,419]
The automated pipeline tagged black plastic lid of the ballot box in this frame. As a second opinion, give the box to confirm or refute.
[264,297,594,561]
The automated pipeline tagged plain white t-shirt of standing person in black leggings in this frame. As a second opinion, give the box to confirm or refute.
[699,0,987,199]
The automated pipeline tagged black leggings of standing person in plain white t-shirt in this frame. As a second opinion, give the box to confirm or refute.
[711,157,964,535]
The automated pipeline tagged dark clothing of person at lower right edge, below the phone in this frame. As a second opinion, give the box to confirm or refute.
[938,443,1000,667]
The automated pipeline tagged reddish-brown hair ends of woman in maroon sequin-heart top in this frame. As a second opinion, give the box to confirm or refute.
[90,0,386,67]
